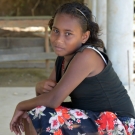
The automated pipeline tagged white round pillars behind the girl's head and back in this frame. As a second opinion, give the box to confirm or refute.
[84,0,134,90]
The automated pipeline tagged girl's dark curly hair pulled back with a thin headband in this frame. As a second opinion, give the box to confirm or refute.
[48,2,104,48]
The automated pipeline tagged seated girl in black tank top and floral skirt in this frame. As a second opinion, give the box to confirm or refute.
[10,2,135,135]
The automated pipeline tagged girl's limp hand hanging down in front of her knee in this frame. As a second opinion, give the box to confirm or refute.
[10,107,30,135]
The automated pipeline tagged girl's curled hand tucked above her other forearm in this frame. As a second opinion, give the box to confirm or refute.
[36,80,56,96]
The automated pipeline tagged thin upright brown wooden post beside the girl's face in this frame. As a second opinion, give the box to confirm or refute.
[45,26,50,71]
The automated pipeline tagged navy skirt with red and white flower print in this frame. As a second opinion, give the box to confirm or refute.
[29,106,135,135]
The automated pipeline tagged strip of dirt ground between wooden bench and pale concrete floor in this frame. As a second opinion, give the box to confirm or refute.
[0,68,52,87]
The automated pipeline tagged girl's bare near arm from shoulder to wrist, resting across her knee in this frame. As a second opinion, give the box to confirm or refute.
[10,49,105,131]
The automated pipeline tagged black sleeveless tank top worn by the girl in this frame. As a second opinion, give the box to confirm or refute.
[56,45,135,118]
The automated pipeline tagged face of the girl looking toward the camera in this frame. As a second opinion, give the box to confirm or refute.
[50,13,87,56]
